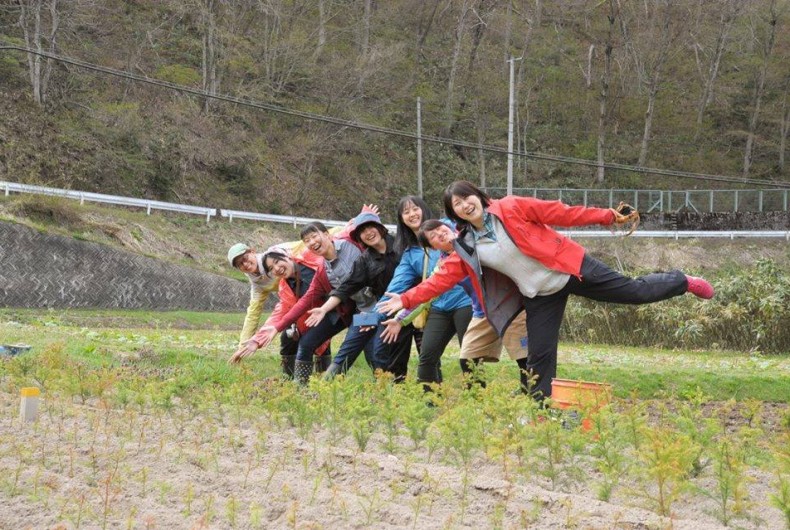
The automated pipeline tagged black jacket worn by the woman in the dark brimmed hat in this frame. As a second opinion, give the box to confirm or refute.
[330,234,401,302]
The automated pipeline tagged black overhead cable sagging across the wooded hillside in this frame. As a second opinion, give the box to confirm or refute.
[0,43,790,188]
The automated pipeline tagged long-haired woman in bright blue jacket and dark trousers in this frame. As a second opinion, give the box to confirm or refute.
[387,195,472,385]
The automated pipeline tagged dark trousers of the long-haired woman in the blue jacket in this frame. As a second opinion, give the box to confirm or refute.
[417,306,472,383]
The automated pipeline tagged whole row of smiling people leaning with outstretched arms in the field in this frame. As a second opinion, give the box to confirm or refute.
[228,181,714,399]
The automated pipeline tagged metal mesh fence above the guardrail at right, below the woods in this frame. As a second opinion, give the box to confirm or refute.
[486,188,790,213]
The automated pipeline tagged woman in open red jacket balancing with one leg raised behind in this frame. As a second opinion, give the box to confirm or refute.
[379,181,714,399]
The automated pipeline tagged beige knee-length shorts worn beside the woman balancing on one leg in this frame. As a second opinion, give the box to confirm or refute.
[460,311,527,362]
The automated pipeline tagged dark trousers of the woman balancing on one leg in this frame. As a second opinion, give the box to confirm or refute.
[524,254,688,399]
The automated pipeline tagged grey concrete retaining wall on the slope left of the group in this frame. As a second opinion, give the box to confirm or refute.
[0,222,249,311]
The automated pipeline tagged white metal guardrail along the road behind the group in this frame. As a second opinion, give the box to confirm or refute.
[0,181,790,241]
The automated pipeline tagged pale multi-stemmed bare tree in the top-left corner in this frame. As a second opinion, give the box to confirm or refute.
[19,0,60,105]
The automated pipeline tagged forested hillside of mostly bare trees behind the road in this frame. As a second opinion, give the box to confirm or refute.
[0,0,790,221]
